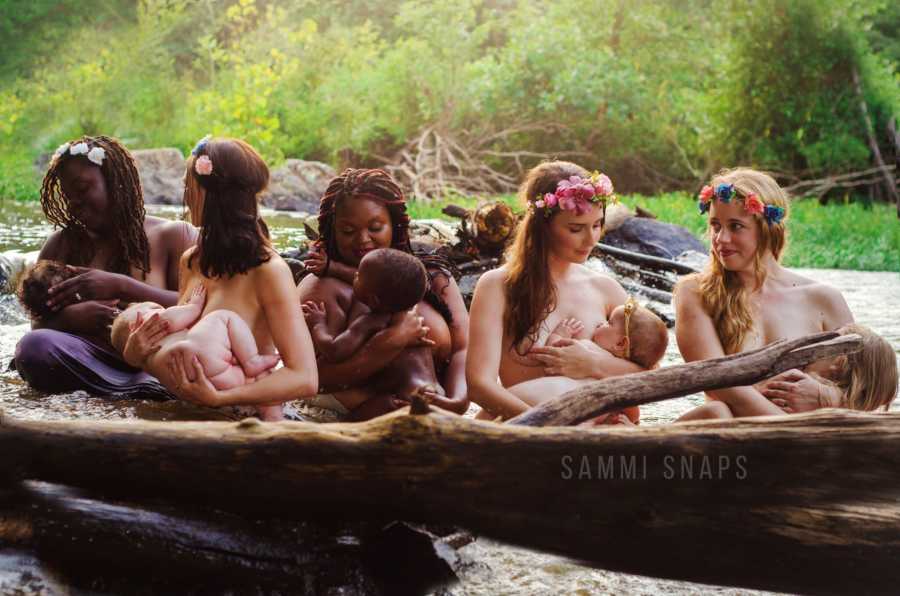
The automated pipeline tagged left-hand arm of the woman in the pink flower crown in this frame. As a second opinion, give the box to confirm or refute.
[466,269,528,419]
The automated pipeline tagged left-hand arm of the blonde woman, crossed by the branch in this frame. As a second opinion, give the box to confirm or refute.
[675,279,784,416]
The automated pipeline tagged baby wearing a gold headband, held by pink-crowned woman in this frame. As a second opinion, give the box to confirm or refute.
[509,298,669,424]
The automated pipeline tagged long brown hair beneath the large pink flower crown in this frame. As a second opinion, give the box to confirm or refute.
[503,161,605,354]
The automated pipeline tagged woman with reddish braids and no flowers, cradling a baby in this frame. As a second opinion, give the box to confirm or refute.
[298,169,469,418]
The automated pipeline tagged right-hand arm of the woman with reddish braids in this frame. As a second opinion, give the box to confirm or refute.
[431,273,469,414]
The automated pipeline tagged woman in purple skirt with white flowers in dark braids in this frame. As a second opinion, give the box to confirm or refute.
[13,136,197,394]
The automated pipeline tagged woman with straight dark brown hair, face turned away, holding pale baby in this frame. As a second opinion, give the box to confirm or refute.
[124,138,318,412]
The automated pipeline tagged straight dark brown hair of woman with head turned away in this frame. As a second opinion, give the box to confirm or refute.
[186,139,271,277]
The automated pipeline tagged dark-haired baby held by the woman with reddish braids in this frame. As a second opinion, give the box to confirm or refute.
[303,248,446,419]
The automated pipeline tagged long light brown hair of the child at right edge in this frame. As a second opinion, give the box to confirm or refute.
[834,323,900,412]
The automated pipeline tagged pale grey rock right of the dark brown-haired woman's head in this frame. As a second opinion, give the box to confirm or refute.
[262,159,336,213]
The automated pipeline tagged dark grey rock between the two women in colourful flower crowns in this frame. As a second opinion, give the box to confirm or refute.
[603,217,708,259]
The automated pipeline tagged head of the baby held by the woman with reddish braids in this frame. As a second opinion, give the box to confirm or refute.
[353,248,428,313]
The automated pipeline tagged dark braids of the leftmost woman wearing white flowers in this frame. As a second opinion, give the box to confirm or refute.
[41,136,150,279]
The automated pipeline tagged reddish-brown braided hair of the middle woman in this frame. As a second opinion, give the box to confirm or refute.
[316,168,455,322]
